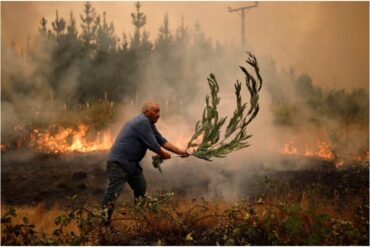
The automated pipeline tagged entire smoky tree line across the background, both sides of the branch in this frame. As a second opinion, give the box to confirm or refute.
[2,2,369,131]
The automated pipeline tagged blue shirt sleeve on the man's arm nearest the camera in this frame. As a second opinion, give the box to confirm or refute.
[134,118,164,153]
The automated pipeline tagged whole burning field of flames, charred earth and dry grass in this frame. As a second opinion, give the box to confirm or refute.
[1,109,369,245]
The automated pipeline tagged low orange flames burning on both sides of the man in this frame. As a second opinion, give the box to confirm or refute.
[1,119,369,168]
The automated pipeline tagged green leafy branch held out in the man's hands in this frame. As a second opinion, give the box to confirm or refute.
[153,52,262,171]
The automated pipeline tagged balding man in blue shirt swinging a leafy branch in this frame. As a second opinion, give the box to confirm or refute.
[102,101,189,224]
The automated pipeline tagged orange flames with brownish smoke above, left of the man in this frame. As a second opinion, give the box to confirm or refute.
[1,101,118,154]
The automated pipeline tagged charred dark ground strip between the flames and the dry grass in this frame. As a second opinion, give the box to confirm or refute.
[1,149,366,206]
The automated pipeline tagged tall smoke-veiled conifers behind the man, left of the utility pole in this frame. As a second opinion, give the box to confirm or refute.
[4,2,225,105]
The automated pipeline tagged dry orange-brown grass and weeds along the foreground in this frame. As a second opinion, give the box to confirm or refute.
[1,164,369,245]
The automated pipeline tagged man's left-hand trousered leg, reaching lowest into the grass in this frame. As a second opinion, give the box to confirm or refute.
[102,162,128,224]
